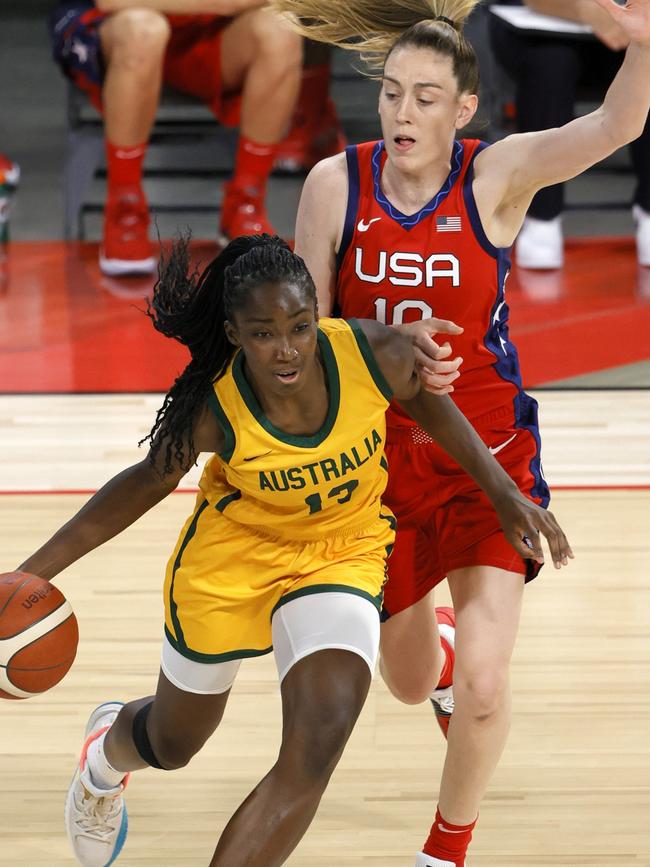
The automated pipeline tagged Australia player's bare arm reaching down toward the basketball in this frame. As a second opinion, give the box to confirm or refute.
[18,407,224,580]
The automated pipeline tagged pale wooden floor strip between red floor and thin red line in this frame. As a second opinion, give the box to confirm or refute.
[0,390,650,493]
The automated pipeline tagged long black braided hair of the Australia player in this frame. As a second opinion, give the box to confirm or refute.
[140,235,316,474]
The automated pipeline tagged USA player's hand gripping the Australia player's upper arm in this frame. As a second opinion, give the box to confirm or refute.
[399,318,463,394]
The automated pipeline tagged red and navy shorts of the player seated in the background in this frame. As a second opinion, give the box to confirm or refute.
[50,0,239,125]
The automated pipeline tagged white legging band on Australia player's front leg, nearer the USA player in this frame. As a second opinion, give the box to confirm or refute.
[272,588,379,681]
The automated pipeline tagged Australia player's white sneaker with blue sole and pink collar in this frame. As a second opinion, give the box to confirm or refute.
[65,701,129,867]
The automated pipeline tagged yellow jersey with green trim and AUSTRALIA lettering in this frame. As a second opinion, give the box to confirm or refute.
[200,319,391,540]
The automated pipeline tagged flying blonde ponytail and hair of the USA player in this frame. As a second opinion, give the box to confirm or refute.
[271,0,480,93]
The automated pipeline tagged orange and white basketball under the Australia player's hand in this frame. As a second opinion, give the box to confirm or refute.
[0,572,79,699]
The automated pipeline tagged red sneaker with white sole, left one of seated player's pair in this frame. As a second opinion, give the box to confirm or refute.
[99,186,156,277]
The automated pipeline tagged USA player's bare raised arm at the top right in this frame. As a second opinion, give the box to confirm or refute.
[475,0,650,234]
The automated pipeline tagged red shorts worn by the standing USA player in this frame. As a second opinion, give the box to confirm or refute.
[383,392,550,619]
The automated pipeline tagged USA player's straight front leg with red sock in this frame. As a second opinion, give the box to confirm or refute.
[424,566,524,865]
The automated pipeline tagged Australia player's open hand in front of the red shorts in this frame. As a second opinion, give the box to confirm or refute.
[496,491,573,569]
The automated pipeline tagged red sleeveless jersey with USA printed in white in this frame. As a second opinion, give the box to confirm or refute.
[335,139,521,425]
